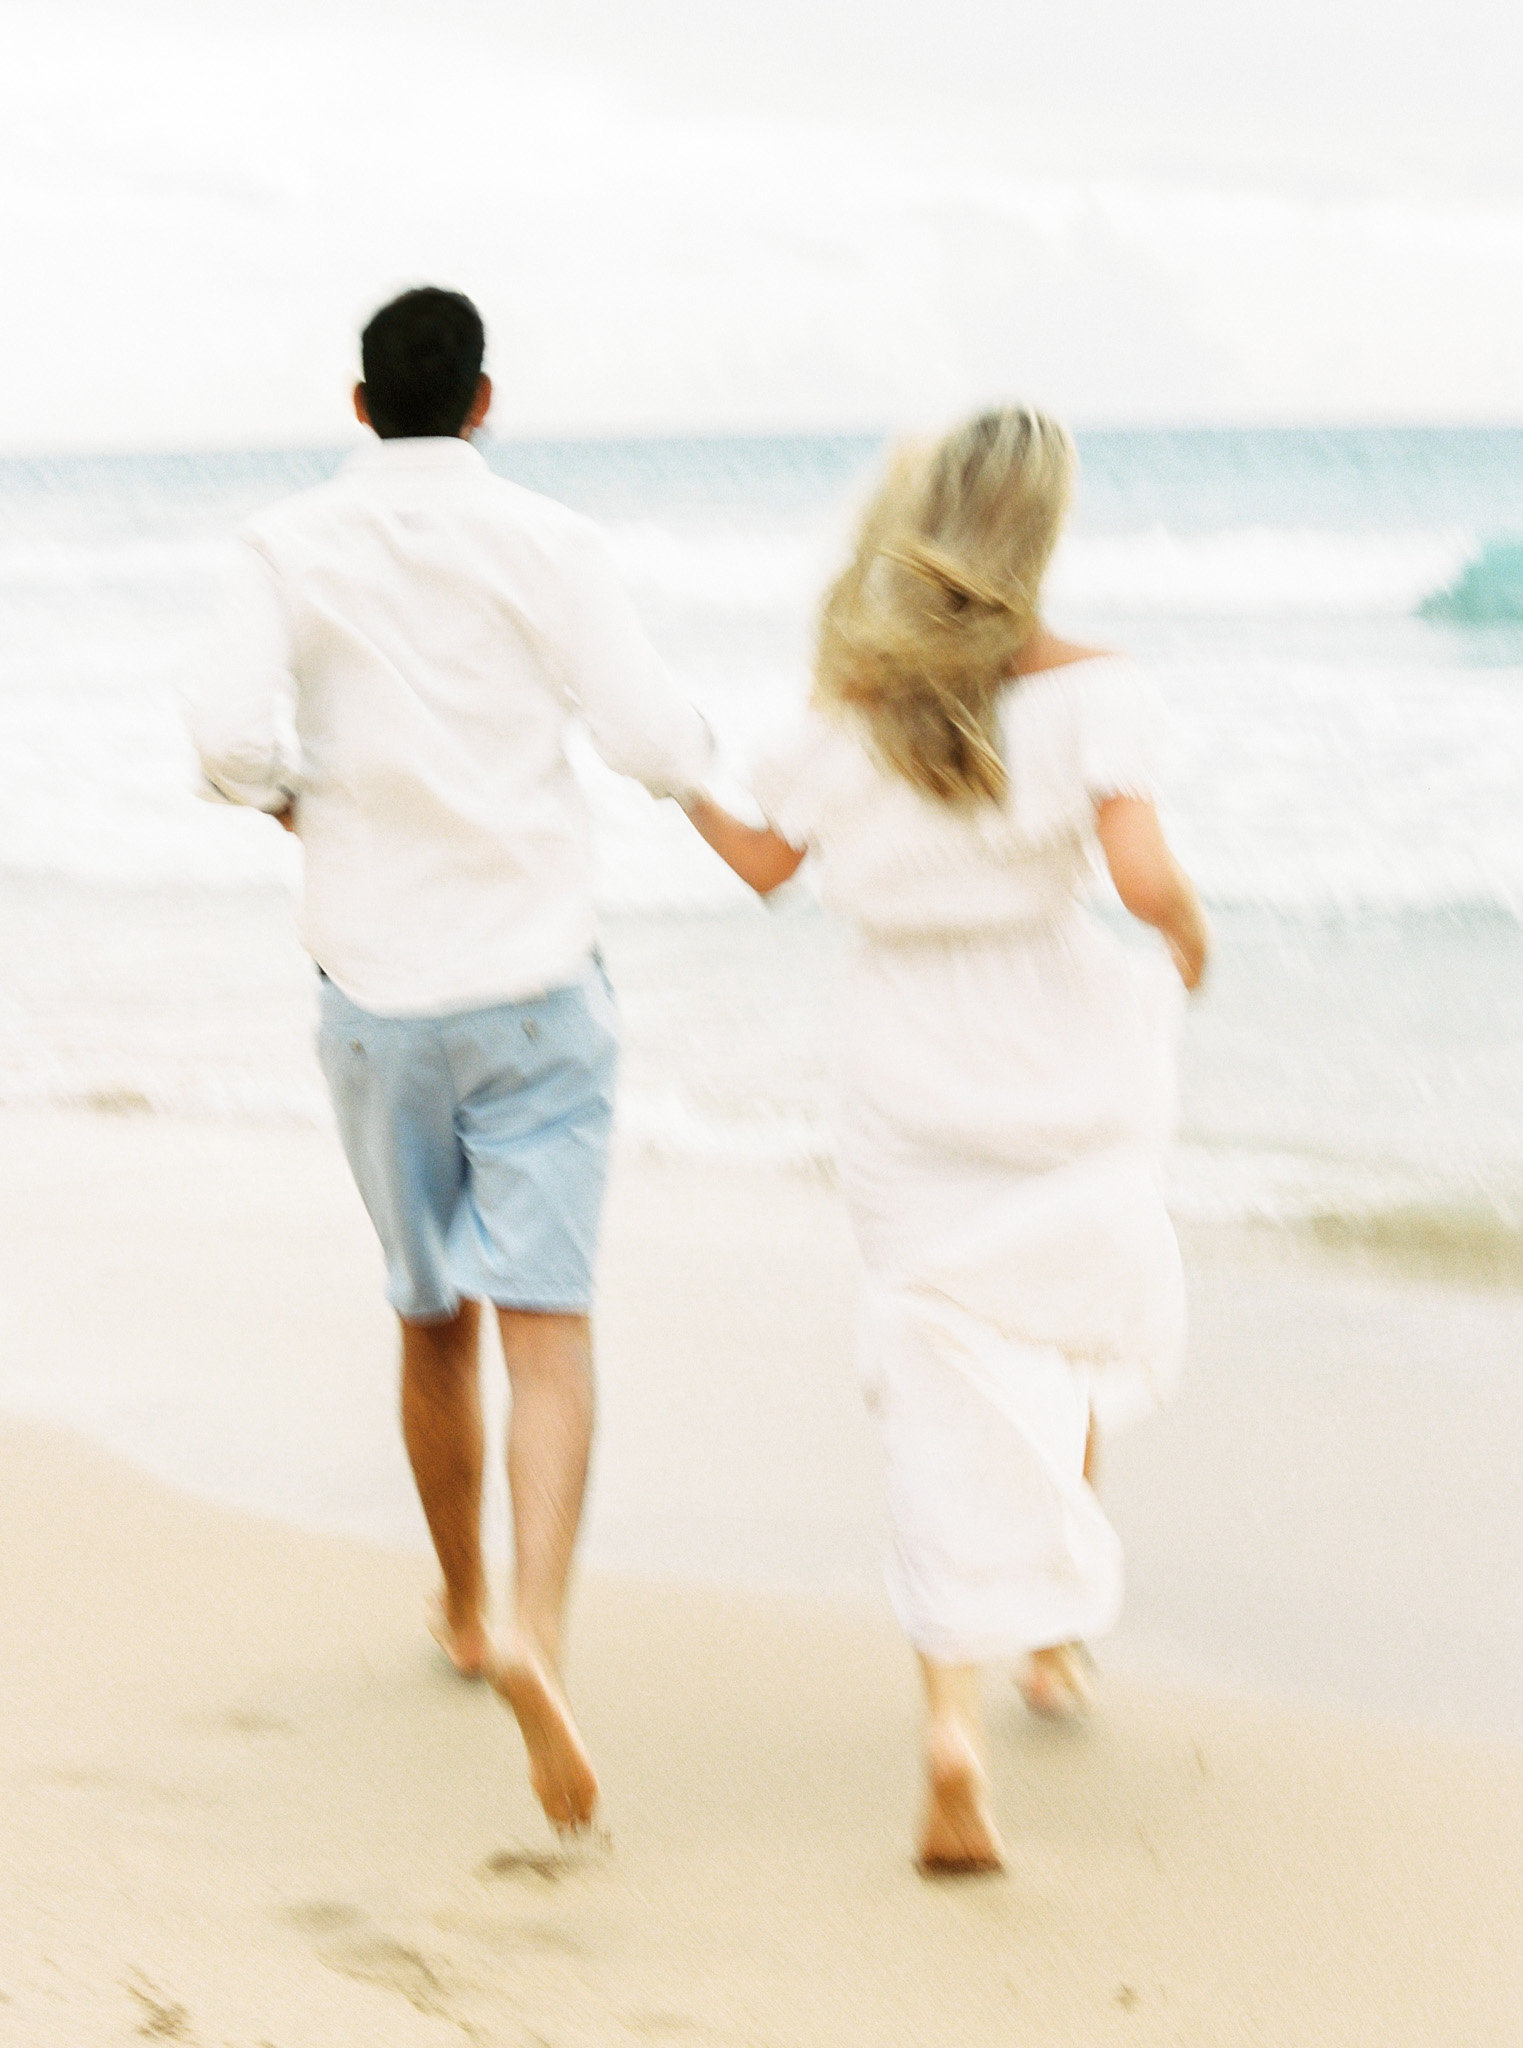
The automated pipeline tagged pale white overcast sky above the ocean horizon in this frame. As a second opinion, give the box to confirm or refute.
[0,0,1523,449]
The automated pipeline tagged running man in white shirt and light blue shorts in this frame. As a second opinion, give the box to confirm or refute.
[192,289,710,1829]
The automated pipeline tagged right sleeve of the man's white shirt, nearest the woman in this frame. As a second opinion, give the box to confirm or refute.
[563,522,714,797]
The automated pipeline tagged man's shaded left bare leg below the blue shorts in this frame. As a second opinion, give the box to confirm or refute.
[401,1300,489,1677]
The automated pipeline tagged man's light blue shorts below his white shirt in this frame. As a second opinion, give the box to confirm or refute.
[317,965,618,1323]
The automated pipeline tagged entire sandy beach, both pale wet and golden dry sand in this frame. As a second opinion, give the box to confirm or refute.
[0,1112,1523,2048]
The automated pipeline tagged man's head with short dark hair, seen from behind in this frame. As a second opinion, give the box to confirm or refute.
[360,285,487,440]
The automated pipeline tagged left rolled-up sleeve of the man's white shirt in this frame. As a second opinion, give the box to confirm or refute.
[190,541,301,825]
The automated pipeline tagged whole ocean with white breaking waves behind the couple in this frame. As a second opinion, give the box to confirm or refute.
[0,428,1523,1278]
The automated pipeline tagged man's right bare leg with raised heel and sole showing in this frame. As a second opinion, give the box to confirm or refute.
[491,1309,598,1831]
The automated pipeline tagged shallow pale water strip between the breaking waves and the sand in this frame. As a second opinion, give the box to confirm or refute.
[0,880,1523,1261]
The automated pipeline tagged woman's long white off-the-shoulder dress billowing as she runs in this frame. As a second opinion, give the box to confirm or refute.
[753,655,1183,1663]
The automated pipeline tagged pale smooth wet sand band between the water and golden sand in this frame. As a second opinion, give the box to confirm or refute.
[0,1110,1523,1735]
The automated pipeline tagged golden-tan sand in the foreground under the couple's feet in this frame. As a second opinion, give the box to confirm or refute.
[0,1423,1523,2048]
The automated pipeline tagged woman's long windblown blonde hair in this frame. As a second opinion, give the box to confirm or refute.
[815,408,1075,805]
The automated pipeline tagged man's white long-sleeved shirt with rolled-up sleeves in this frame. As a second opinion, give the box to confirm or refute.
[192,438,710,1016]
